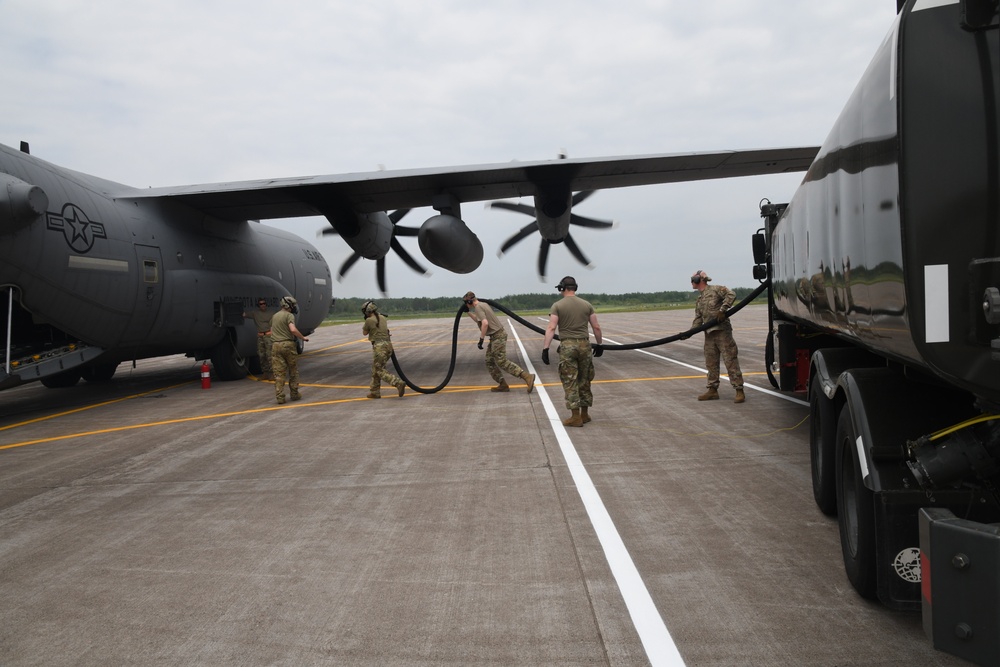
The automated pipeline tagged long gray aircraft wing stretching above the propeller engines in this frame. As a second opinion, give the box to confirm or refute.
[124,146,819,221]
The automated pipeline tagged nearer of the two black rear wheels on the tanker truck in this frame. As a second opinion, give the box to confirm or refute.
[836,406,878,599]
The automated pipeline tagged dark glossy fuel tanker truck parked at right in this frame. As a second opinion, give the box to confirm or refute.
[753,0,1000,665]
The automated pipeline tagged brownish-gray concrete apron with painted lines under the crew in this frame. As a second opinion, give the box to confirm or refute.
[0,306,967,667]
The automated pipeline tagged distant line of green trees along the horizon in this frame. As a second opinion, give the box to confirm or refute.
[330,287,754,320]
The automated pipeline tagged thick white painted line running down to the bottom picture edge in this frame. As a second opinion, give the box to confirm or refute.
[508,320,684,667]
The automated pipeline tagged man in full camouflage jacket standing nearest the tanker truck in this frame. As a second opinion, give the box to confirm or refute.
[691,271,746,403]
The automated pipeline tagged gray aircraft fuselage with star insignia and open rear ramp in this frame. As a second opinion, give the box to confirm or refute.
[0,145,331,388]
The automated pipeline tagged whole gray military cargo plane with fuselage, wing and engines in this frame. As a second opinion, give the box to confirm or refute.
[0,143,819,389]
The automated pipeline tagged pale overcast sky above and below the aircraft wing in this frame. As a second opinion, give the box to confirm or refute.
[0,0,895,298]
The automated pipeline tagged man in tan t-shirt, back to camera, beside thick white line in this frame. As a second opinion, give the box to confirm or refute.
[542,276,604,426]
